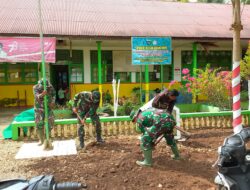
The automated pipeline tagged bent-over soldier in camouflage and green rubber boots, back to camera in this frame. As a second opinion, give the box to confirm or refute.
[130,108,180,166]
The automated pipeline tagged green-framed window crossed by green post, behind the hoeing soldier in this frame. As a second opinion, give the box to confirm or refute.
[90,50,113,83]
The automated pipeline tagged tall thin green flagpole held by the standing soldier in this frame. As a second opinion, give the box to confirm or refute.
[38,0,49,141]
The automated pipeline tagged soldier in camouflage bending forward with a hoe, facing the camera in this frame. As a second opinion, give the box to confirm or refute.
[73,91,104,149]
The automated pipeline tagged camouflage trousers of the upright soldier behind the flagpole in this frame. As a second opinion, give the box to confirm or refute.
[35,109,55,130]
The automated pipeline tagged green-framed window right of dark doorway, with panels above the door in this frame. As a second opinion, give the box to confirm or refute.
[56,49,84,83]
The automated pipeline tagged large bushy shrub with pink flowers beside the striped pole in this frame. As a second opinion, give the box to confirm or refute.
[170,65,232,109]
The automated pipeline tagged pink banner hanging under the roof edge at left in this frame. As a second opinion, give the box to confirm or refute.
[0,37,56,63]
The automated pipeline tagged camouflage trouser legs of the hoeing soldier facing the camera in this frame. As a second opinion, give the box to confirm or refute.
[78,112,102,148]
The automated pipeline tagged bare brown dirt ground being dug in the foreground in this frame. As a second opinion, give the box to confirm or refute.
[0,129,232,190]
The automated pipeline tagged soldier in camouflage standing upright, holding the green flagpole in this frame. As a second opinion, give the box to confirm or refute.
[33,79,56,148]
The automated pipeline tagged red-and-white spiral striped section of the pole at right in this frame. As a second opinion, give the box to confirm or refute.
[232,61,242,133]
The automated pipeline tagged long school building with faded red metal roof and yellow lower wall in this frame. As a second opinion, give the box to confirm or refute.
[0,0,250,106]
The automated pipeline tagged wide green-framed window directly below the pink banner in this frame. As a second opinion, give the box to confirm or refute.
[0,63,38,84]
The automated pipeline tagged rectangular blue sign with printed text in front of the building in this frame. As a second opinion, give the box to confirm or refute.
[131,37,172,65]
